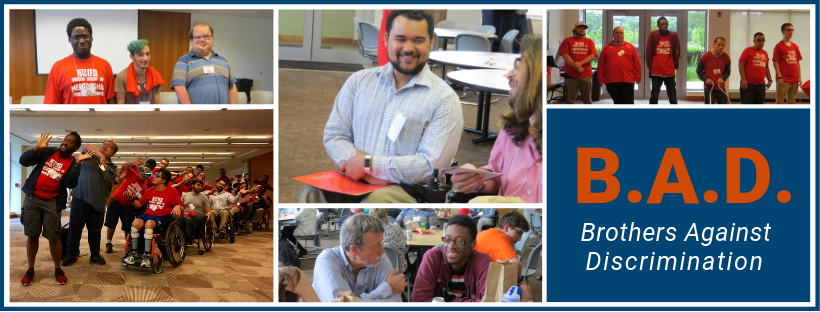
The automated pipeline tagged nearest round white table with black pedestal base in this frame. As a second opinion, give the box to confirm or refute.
[447,69,510,144]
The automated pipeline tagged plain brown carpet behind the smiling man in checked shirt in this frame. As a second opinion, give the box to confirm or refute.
[278,68,509,203]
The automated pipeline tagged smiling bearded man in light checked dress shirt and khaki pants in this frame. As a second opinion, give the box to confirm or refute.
[299,10,464,203]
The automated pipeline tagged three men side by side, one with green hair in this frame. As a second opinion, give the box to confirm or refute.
[43,18,238,104]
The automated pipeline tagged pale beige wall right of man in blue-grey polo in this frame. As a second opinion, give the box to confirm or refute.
[191,11,273,91]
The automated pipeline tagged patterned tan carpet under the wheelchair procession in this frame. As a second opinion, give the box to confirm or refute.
[8,211,273,302]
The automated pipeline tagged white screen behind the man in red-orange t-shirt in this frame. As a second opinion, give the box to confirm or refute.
[34,10,139,75]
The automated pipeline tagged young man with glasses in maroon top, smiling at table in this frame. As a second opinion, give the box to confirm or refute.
[413,215,532,302]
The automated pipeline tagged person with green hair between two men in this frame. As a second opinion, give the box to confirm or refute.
[114,39,165,104]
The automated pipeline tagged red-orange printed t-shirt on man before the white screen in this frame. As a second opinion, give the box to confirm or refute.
[43,55,116,104]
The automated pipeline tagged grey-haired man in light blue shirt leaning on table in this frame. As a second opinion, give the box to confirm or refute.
[313,213,406,302]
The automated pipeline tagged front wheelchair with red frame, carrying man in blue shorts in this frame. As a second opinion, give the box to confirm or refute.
[122,217,187,274]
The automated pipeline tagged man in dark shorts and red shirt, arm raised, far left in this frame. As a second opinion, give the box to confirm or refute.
[20,132,82,286]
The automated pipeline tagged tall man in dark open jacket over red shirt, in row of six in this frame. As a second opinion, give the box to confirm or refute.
[646,16,680,104]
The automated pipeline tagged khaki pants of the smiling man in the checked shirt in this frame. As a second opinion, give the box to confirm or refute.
[299,185,416,203]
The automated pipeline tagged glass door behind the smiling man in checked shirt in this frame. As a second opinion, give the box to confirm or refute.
[279,10,378,64]
